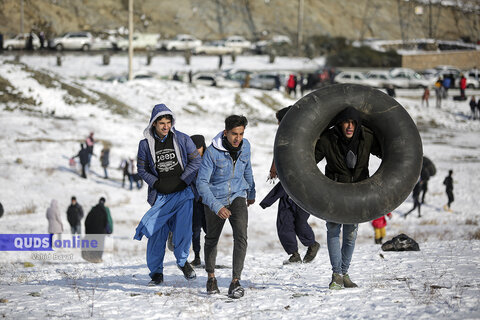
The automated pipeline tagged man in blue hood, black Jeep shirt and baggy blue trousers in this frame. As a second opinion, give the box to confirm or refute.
[134,104,202,285]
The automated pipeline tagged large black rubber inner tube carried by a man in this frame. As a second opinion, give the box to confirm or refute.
[274,84,423,224]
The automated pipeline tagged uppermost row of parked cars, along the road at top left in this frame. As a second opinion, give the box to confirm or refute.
[3,32,291,55]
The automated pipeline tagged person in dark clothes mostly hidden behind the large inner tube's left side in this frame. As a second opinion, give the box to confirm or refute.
[260,106,320,264]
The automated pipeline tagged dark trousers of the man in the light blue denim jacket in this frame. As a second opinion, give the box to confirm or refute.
[205,197,248,279]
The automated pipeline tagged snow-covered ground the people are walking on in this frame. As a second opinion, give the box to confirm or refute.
[0,56,480,319]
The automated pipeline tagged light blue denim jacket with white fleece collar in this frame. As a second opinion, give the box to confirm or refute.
[196,132,255,213]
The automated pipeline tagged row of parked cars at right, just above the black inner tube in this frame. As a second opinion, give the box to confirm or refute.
[334,66,480,89]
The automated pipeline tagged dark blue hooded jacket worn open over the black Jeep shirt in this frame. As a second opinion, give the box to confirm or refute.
[137,104,202,206]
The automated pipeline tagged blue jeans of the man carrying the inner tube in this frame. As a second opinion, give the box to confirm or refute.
[327,222,358,274]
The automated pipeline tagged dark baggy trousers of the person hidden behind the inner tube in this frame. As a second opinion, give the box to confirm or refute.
[277,207,315,255]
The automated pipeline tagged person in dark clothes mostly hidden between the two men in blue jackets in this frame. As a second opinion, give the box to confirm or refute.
[190,134,207,267]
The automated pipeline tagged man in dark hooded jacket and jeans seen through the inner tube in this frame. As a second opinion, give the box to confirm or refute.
[315,107,381,290]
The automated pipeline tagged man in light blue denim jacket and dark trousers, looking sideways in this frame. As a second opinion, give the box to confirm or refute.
[195,115,255,299]
